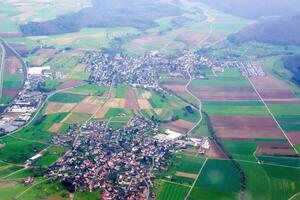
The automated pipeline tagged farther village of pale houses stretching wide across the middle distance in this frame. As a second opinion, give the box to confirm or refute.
[82,51,264,88]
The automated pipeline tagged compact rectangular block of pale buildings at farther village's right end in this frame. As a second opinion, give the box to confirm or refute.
[236,62,265,77]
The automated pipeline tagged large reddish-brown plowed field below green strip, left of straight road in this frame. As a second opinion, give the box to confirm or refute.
[211,116,285,139]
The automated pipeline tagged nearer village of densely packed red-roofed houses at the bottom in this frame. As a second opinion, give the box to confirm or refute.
[48,116,174,199]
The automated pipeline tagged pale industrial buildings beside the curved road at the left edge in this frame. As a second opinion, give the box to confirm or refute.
[0,67,52,135]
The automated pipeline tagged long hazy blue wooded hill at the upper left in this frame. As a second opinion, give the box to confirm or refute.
[20,0,182,36]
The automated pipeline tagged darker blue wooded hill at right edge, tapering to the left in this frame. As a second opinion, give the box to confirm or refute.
[229,15,300,45]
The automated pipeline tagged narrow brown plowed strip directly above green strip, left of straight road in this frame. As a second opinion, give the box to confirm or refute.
[193,92,259,101]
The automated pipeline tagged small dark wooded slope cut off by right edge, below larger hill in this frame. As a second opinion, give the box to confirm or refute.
[283,55,300,86]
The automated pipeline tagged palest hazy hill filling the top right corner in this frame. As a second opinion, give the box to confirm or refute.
[195,0,300,19]
